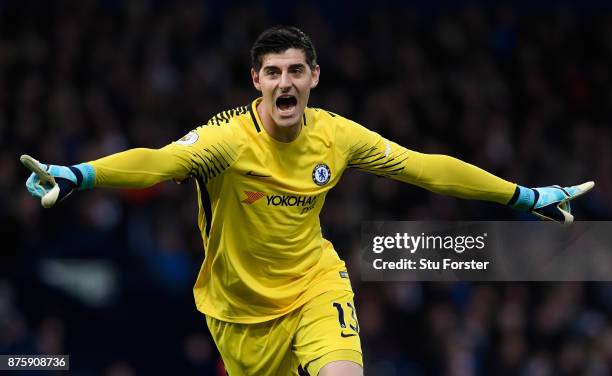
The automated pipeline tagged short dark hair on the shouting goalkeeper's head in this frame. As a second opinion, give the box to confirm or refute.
[251,25,317,71]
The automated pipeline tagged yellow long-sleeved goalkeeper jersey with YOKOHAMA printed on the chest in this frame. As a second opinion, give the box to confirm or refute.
[91,99,515,323]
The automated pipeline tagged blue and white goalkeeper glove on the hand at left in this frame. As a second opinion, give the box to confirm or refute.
[20,155,96,208]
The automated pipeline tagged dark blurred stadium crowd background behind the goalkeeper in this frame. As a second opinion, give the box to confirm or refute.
[0,0,612,376]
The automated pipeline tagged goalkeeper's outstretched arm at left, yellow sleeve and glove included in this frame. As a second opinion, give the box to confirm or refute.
[21,122,241,208]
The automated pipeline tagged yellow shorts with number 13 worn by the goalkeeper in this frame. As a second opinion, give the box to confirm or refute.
[206,290,363,376]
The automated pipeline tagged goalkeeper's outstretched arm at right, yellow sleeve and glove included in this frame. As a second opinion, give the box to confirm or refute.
[338,119,595,223]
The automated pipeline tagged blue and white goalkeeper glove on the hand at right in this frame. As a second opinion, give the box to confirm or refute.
[508,181,595,224]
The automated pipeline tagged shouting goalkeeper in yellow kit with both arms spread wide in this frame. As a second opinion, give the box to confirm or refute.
[22,26,594,376]
